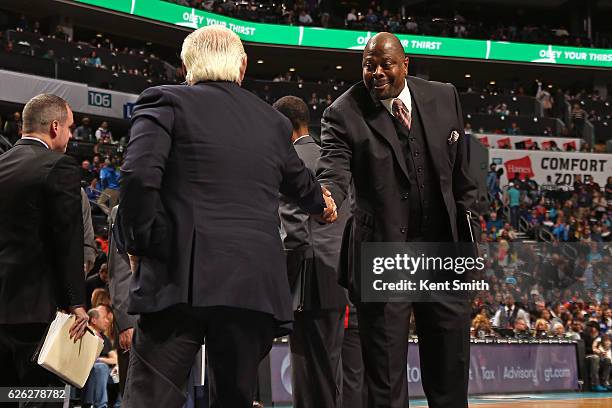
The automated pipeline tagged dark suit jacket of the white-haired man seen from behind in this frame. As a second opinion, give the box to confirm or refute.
[118,82,324,334]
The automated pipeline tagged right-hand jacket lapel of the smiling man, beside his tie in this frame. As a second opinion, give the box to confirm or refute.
[406,76,448,176]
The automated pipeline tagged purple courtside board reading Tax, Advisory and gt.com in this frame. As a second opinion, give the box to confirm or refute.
[270,343,578,403]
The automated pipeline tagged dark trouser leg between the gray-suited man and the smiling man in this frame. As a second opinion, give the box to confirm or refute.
[342,327,368,408]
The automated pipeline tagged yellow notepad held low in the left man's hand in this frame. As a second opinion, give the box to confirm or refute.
[38,312,104,388]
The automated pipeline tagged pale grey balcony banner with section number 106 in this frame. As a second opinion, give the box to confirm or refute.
[0,70,138,119]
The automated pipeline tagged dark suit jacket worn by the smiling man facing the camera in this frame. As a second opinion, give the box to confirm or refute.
[317,77,477,297]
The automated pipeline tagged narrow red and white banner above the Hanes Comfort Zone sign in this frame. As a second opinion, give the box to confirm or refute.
[474,133,583,151]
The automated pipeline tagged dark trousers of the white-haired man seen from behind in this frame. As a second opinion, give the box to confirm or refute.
[122,305,276,408]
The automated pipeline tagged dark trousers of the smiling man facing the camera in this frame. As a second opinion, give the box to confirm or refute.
[357,301,470,408]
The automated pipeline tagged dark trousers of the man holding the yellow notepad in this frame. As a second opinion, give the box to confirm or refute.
[0,323,64,408]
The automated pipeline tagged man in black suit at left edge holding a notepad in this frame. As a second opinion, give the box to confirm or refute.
[0,94,88,396]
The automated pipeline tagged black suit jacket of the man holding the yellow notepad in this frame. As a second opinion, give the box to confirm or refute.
[0,139,85,324]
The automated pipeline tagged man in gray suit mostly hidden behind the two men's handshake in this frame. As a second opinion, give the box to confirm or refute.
[274,96,350,408]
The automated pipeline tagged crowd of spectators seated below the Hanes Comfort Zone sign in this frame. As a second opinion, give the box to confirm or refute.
[472,159,612,391]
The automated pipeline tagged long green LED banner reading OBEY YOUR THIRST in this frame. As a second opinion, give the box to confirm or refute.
[76,0,612,67]
